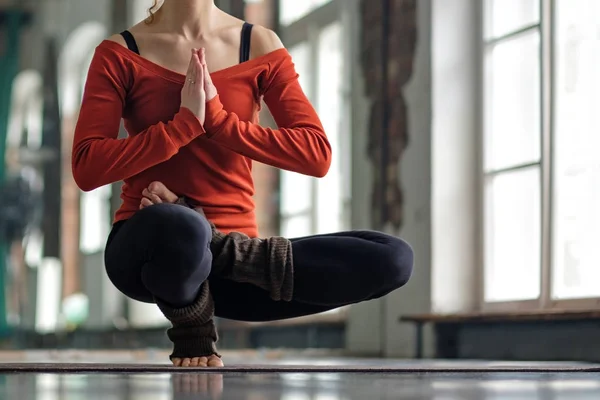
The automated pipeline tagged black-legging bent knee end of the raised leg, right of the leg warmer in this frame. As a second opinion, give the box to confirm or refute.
[292,231,413,306]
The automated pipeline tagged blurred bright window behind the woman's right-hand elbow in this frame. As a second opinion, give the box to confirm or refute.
[280,1,351,237]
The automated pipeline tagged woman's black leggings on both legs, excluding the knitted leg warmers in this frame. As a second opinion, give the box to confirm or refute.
[105,204,413,321]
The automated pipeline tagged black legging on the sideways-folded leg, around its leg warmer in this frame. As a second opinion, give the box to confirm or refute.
[210,231,412,322]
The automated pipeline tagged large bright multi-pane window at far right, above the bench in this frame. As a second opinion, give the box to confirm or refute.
[483,0,600,308]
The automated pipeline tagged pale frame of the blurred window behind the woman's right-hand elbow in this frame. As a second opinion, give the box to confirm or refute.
[276,0,353,238]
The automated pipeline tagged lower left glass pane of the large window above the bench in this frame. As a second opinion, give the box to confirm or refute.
[485,168,541,302]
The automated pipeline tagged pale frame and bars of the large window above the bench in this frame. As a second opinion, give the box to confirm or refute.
[477,0,600,312]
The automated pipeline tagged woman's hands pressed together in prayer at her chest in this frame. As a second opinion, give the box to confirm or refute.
[181,48,217,123]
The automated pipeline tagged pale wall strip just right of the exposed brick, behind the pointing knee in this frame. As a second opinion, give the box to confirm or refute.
[383,0,432,357]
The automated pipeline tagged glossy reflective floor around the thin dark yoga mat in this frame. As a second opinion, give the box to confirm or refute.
[0,352,600,400]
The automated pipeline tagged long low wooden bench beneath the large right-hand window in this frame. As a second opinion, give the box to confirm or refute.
[399,309,600,358]
